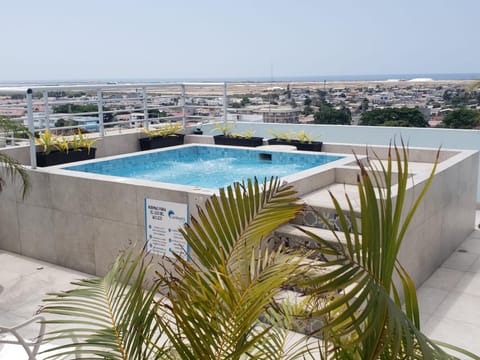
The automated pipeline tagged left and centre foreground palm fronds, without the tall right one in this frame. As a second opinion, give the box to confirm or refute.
[43,179,316,359]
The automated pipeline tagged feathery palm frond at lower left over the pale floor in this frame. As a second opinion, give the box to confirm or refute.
[41,250,162,360]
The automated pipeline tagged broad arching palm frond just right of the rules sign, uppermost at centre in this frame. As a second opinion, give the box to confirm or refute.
[182,178,301,271]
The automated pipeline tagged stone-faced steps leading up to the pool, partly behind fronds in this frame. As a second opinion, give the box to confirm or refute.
[262,184,368,339]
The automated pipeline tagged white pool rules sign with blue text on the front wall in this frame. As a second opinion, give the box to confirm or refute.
[145,199,189,260]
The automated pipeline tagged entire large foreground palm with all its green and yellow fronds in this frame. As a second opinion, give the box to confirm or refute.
[43,148,479,359]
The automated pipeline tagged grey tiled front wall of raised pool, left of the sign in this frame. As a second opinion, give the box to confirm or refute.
[0,169,211,275]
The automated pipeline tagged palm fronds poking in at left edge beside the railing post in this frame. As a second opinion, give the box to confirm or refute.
[0,118,30,197]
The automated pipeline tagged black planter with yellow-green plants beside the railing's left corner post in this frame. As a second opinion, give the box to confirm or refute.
[35,129,97,167]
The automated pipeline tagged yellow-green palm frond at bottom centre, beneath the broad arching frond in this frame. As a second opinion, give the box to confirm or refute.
[159,249,306,359]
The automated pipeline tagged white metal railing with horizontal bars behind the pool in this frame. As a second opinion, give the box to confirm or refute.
[0,83,228,168]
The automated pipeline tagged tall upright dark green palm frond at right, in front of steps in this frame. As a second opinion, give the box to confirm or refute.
[298,146,478,359]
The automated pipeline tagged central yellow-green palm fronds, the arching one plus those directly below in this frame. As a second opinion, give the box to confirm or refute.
[159,179,304,359]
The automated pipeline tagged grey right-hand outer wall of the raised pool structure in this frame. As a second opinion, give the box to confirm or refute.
[399,151,479,286]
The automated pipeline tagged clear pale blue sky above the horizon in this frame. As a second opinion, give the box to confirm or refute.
[0,0,480,82]
